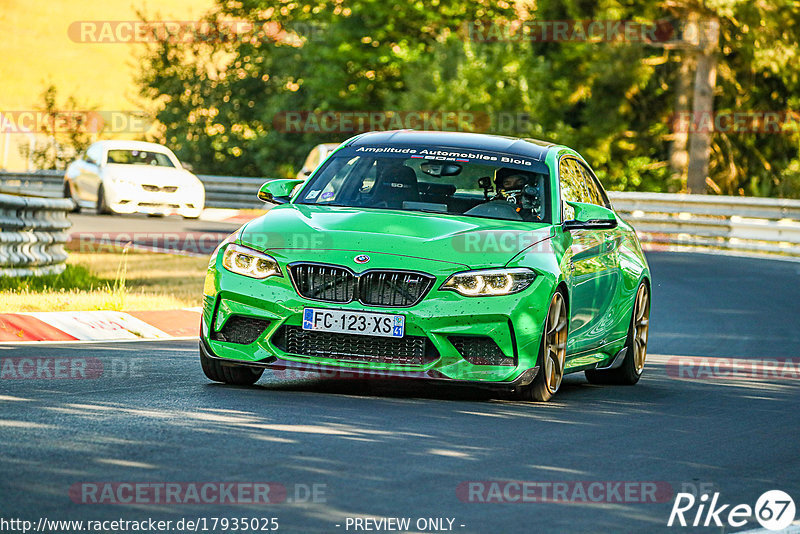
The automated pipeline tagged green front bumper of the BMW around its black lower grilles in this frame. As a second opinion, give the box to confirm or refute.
[201,255,552,388]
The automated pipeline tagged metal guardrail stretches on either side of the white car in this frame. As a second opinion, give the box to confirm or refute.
[0,171,270,209]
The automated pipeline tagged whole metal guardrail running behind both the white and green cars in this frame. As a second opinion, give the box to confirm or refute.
[0,171,800,257]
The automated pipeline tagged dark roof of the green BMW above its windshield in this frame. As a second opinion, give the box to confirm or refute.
[348,130,557,160]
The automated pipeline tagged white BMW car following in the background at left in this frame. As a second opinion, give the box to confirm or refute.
[64,141,205,219]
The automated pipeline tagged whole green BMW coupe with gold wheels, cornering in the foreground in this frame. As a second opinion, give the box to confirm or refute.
[200,130,651,401]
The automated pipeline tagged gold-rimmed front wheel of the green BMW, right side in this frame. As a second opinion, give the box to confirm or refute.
[520,291,569,402]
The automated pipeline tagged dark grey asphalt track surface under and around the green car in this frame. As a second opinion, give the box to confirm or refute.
[0,253,800,533]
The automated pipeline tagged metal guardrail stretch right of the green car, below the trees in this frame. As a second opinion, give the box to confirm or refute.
[609,192,800,257]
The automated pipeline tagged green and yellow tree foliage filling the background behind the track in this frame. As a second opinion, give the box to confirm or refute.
[140,0,800,196]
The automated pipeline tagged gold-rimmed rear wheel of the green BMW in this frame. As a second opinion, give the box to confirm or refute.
[585,282,650,386]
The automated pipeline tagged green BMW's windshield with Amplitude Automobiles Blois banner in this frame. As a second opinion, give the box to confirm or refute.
[297,148,550,222]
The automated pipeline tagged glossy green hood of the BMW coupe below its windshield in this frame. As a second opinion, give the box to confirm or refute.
[239,204,552,268]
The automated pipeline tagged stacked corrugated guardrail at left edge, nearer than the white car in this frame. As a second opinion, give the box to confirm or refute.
[0,194,73,277]
